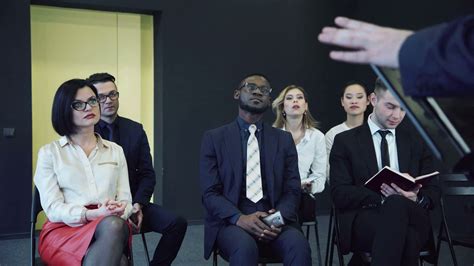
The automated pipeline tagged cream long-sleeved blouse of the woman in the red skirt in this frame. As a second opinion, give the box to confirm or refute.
[34,134,132,227]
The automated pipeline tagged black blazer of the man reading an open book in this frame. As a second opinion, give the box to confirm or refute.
[329,124,440,253]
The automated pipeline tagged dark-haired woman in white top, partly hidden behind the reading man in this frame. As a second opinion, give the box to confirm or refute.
[325,82,370,162]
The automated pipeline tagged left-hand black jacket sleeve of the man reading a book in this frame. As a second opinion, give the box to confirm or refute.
[329,134,381,209]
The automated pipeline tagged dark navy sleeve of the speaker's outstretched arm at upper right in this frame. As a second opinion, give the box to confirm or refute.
[399,15,474,96]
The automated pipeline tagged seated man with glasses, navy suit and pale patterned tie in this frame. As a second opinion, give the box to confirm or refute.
[200,74,311,266]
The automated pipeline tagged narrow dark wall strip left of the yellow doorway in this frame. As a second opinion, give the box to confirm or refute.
[0,0,32,235]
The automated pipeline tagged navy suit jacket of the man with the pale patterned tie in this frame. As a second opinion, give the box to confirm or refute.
[199,121,301,259]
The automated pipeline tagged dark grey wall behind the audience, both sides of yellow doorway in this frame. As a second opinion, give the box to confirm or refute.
[0,0,474,235]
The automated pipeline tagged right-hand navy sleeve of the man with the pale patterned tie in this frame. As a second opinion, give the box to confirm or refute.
[276,133,301,222]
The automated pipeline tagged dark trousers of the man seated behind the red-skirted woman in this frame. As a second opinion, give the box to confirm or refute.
[142,203,188,265]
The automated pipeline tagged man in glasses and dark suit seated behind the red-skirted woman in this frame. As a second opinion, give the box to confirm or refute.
[88,73,187,265]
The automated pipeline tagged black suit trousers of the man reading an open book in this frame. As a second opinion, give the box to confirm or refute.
[351,195,431,266]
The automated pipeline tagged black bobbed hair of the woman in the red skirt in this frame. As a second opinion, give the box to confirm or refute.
[51,79,99,136]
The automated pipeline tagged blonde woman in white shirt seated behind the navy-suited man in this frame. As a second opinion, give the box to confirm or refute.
[272,85,327,194]
